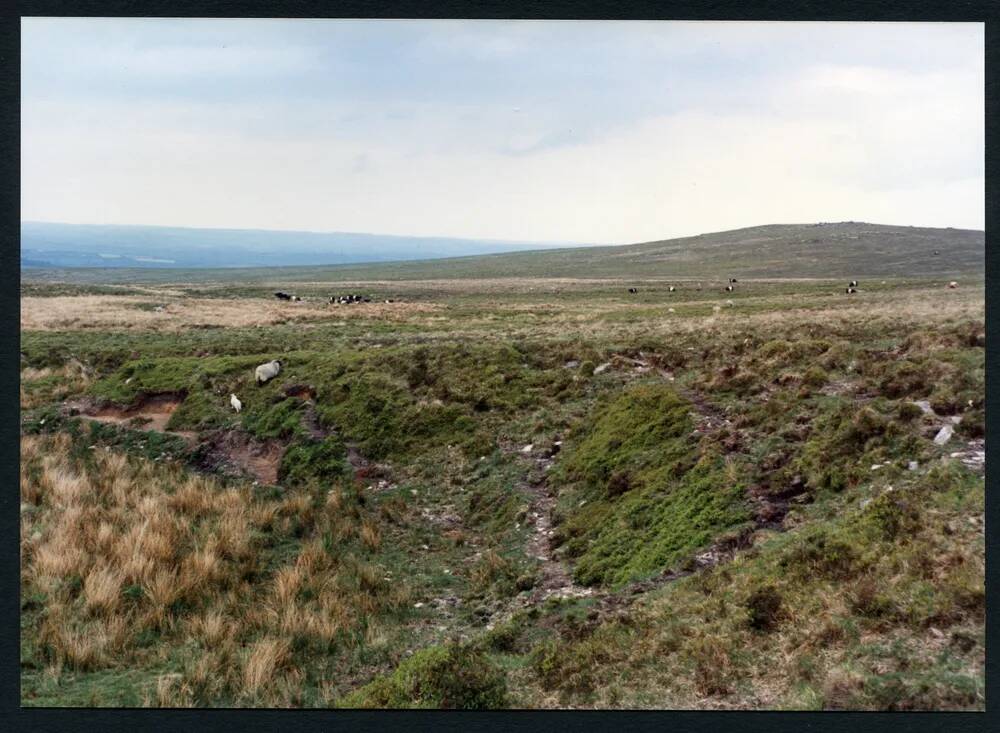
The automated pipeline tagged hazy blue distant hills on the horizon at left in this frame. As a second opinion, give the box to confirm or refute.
[21,222,579,268]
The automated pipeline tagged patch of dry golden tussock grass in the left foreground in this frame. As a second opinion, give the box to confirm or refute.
[21,435,408,706]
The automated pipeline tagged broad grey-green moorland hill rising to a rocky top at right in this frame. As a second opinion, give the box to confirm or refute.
[21,222,986,282]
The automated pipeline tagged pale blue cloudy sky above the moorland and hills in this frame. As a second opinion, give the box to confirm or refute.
[21,18,985,243]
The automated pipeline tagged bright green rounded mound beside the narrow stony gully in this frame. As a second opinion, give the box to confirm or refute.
[559,385,749,585]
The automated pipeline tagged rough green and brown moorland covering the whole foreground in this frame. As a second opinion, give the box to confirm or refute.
[21,270,985,710]
